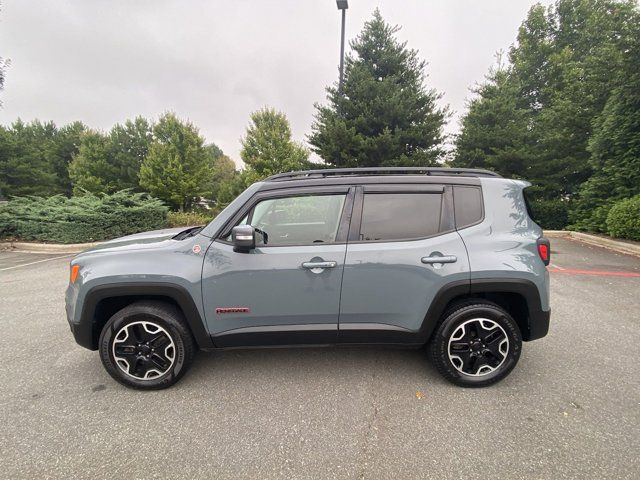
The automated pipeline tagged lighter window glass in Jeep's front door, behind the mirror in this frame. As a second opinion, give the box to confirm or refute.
[240,194,346,246]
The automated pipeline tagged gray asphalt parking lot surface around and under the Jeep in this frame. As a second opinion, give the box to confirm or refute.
[0,239,640,479]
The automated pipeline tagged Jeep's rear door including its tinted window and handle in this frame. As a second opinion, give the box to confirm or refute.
[338,185,469,343]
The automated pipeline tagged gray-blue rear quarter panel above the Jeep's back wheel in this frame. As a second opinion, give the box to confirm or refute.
[459,178,549,311]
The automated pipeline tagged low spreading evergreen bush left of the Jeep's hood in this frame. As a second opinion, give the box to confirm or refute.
[0,190,167,243]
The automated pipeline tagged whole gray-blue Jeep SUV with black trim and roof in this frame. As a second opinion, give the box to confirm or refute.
[66,168,550,389]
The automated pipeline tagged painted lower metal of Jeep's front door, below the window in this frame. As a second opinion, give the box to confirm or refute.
[202,241,346,336]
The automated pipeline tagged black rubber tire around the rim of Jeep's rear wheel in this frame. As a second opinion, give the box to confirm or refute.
[433,304,522,387]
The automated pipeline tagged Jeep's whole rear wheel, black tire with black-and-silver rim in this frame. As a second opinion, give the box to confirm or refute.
[428,300,522,387]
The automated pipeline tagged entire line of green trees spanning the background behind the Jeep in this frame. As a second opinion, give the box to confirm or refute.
[0,0,640,231]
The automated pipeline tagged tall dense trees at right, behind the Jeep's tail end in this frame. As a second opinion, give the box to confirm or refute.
[452,0,640,232]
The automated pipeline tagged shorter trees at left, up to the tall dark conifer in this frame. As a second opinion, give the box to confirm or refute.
[0,108,309,211]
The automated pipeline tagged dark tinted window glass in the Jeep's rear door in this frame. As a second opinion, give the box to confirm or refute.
[360,193,442,241]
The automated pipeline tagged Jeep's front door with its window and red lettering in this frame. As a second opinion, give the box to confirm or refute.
[202,187,353,347]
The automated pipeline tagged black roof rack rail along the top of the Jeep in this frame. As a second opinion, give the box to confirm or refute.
[264,167,502,182]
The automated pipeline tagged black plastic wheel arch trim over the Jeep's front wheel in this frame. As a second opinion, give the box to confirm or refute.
[74,283,213,350]
